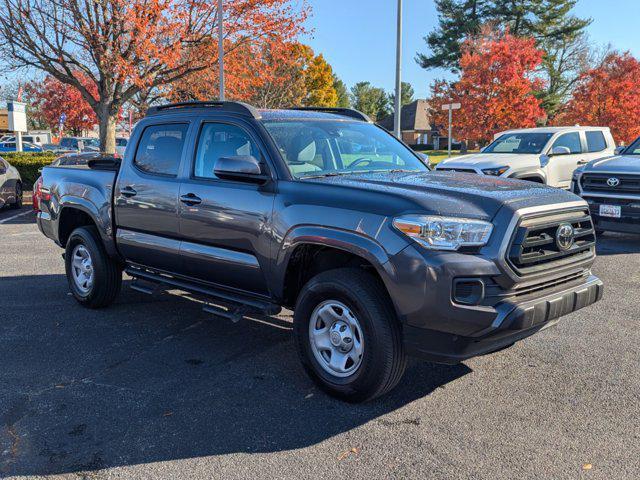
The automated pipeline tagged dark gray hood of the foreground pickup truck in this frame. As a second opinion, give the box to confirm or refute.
[305,172,580,220]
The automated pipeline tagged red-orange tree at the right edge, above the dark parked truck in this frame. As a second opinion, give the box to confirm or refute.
[554,52,640,143]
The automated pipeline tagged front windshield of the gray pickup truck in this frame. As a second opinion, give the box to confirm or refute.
[264,120,429,178]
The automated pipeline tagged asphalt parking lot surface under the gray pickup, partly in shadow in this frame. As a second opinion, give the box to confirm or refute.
[0,204,640,479]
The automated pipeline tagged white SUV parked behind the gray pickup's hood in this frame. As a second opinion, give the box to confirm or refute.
[436,127,615,189]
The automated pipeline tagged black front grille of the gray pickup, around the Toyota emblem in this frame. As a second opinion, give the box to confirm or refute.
[507,209,596,276]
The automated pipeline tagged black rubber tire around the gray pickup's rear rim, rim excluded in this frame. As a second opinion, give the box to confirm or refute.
[65,226,122,308]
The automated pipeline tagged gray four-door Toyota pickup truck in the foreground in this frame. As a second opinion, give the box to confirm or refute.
[38,102,603,402]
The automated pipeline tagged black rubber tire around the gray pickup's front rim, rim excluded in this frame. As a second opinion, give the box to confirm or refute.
[293,268,407,402]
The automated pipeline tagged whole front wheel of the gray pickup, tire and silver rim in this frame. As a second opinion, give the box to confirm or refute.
[294,268,406,402]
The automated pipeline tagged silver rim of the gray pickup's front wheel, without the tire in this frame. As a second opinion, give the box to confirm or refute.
[309,300,364,377]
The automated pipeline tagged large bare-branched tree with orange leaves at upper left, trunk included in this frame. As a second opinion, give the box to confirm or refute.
[0,0,309,153]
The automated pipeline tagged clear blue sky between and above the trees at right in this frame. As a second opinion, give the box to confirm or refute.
[305,0,640,97]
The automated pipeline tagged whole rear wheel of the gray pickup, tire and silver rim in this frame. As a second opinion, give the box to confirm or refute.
[65,227,122,308]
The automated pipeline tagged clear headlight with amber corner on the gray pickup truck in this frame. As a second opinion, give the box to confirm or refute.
[393,215,493,250]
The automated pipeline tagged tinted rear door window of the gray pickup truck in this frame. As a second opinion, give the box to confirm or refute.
[133,123,189,177]
